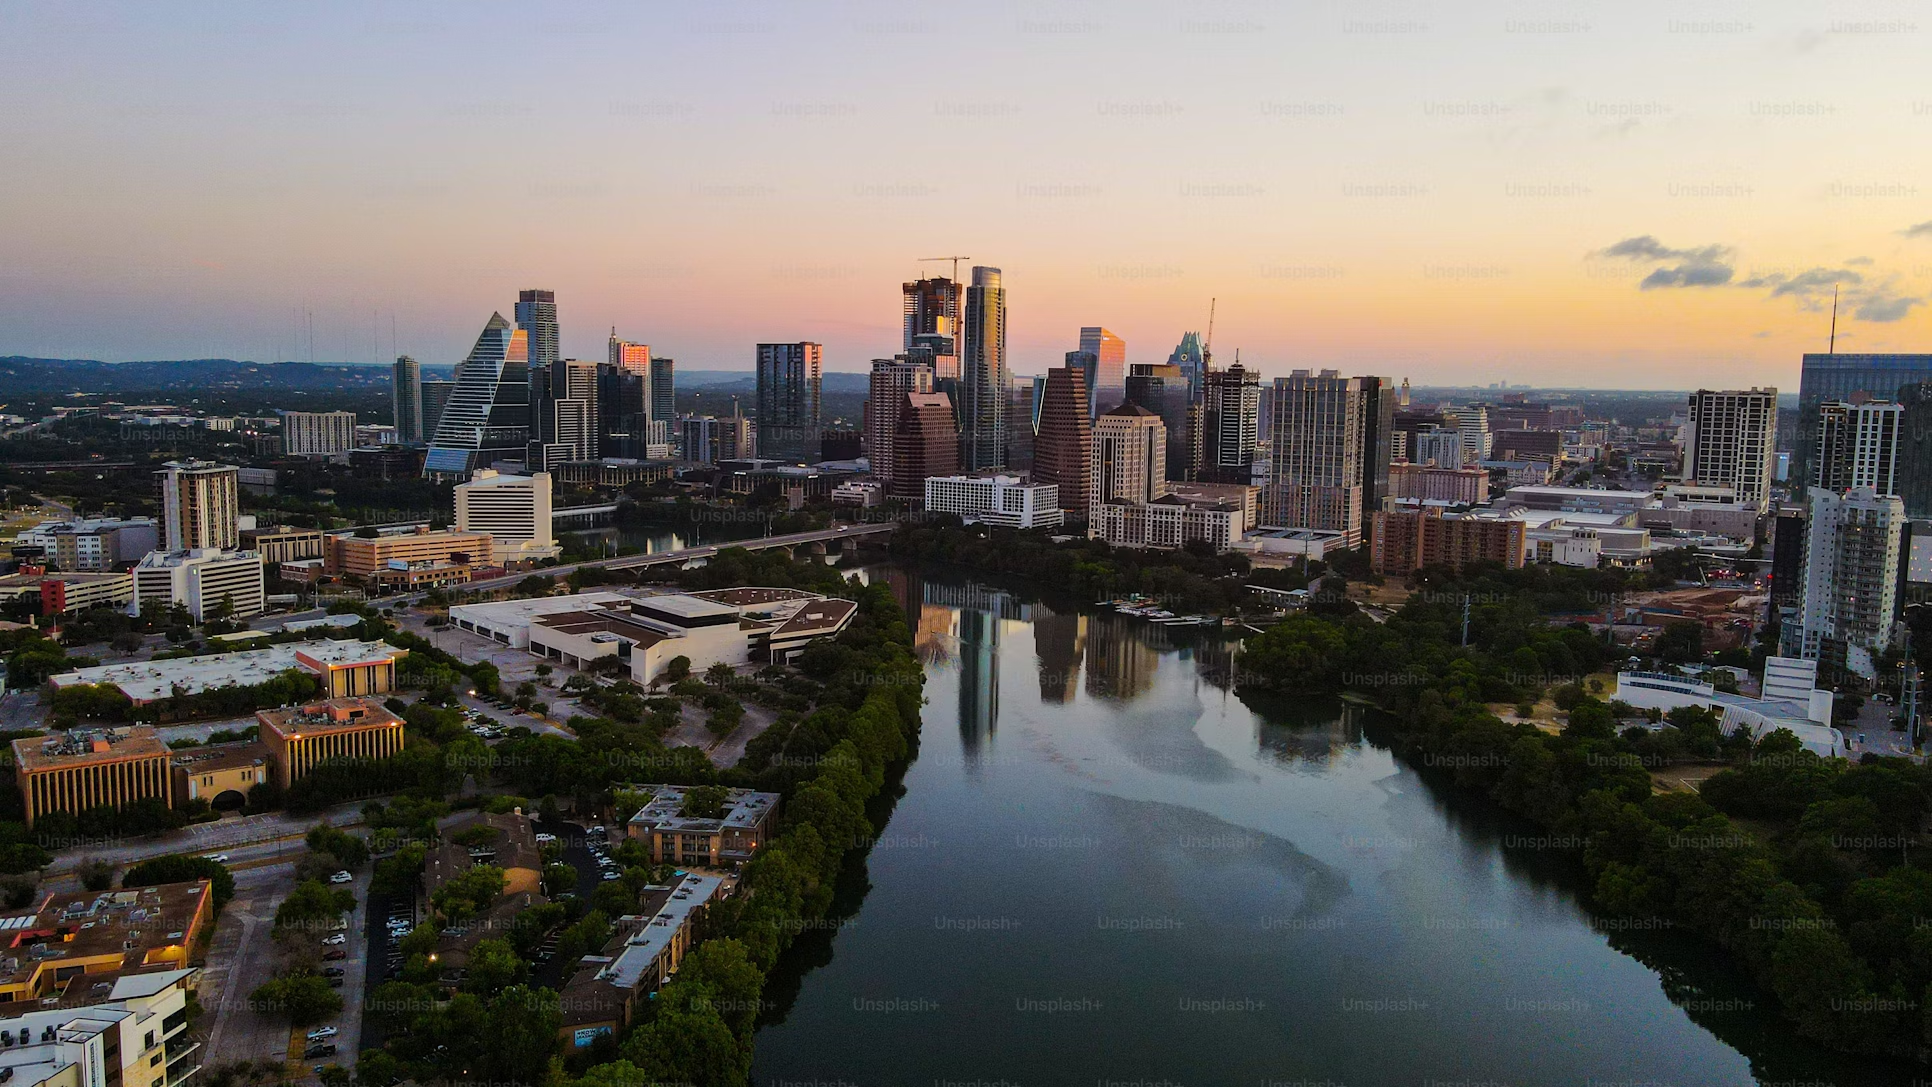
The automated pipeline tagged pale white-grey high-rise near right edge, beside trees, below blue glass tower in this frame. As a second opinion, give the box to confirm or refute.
[1785,487,1905,678]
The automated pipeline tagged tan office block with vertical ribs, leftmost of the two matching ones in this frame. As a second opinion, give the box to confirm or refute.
[14,724,174,826]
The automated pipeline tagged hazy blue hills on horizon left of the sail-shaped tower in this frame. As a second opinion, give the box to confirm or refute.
[0,355,429,394]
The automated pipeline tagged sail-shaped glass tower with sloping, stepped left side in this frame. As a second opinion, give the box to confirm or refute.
[423,313,529,479]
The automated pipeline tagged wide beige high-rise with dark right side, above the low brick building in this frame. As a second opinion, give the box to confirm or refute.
[1262,371,1378,548]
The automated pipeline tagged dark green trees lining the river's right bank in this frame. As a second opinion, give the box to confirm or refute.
[891,525,1932,1062]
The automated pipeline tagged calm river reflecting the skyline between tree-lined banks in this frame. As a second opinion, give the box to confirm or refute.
[753,570,1911,1087]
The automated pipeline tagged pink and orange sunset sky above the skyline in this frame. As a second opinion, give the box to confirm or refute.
[0,0,1932,388]
